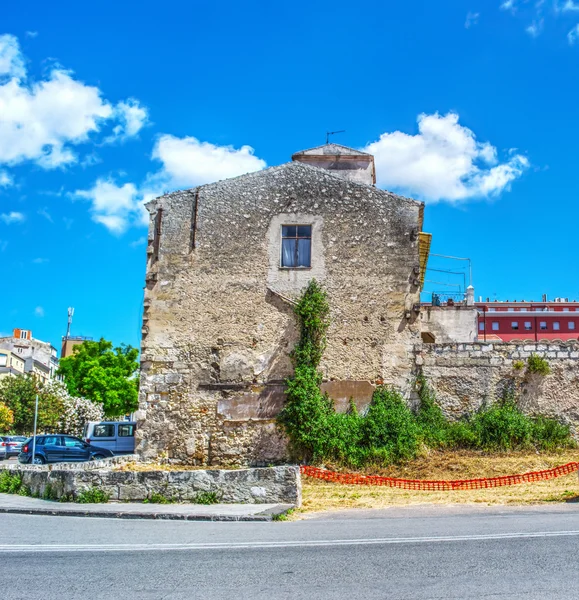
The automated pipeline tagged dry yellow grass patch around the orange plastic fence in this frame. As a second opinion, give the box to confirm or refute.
[297,450,579,514]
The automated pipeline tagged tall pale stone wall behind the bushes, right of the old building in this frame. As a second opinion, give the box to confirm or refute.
[415,342,579,436]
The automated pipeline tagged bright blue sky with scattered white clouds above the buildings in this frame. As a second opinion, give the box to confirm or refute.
[0,0,579,346]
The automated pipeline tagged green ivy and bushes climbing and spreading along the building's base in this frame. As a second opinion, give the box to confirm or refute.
[279,280,574,467]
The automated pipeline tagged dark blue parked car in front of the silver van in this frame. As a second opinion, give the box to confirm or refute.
[18,434,113,465]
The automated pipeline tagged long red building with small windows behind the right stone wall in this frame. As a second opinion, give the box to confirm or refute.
[475,298,579,342]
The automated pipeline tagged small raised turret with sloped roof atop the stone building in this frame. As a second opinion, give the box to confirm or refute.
[292,144,376,185]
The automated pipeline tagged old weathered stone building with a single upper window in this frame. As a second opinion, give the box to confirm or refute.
[137,144,430,465]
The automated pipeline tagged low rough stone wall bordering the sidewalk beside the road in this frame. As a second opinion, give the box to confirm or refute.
[0,457,301,506]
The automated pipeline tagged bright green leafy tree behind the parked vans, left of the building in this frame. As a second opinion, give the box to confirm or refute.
[58,338,139,417]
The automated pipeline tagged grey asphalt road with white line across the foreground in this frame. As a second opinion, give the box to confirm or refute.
[0,505,579,600]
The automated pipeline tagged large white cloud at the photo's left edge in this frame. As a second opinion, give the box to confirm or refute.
[0,35,147,178]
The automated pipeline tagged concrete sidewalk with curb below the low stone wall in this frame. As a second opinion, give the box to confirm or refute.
[0,494,293,521]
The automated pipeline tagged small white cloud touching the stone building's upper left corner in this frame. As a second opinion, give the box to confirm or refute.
[74,178,141,234]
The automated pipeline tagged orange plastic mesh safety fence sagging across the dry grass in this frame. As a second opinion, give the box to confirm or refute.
[300,462,579,492]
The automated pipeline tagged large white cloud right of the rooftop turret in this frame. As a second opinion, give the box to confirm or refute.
[363,113,529,202]
